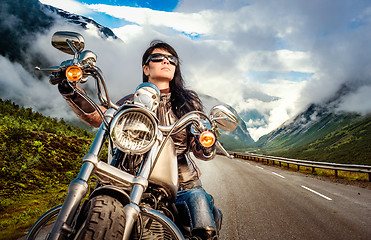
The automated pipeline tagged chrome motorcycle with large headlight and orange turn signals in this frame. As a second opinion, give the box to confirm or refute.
[26,31,238,240]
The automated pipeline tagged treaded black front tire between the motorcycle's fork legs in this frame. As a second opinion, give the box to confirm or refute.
[76,195,125,240]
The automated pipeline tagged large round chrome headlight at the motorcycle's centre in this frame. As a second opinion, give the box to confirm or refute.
[111,108,157,153]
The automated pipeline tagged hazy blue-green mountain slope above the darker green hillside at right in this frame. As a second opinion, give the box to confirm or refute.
[256,85,370,161]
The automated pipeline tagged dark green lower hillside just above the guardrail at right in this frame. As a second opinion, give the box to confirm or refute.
[269,115,371,165]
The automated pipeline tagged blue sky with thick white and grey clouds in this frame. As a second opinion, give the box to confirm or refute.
[9,0,371,140]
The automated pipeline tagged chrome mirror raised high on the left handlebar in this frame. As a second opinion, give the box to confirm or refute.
[52,31,85,55]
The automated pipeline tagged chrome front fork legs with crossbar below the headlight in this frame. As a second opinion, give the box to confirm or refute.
[48,115,159,240]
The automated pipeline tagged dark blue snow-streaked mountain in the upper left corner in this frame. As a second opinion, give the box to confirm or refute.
[0,0,118,72]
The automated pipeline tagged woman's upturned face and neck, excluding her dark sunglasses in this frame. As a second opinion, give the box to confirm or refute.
[143,48,176,89]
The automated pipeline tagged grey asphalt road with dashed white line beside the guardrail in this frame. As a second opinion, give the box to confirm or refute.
[197,156,371,240]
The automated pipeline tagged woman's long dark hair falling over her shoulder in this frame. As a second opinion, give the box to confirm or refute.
[142,40,203,118]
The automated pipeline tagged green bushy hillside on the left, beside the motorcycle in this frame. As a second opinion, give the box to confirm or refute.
[0,99,93,239]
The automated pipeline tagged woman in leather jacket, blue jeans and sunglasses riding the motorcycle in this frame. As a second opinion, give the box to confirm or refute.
[58,41,222,239]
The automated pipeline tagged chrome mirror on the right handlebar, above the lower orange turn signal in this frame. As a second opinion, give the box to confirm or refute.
[210,105,238,132]
